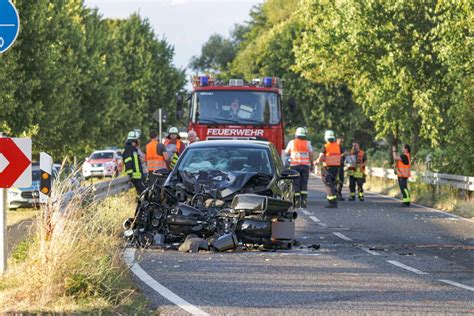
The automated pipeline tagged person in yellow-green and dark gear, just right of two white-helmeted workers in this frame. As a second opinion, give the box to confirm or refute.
[347,143,367,201]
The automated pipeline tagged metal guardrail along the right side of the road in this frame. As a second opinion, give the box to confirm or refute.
[366,167,474,191]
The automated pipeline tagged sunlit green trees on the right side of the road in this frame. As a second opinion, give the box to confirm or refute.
[192,0,474,174]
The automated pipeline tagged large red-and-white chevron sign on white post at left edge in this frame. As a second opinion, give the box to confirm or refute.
[0,137,32,274]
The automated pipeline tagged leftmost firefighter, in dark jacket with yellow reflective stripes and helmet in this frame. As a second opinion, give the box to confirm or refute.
[123,131,145,195]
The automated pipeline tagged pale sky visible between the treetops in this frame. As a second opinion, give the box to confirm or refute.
[85,0,263,68]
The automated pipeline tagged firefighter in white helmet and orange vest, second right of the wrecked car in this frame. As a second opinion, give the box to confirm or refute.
[315,130,341,208]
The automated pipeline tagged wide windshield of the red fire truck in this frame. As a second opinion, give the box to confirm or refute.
[191,90,281,125]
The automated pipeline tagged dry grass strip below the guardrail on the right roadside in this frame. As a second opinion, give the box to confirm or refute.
[365,177,474,219]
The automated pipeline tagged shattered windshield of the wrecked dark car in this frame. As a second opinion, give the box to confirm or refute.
[178,146,273,175]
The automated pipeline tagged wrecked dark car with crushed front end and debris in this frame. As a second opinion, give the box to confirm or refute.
[124,140,299,251]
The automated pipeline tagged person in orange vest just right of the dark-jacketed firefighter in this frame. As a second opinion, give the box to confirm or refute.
[145,129,169,186]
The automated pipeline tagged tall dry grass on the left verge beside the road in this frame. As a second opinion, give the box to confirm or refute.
[0,167,150,314]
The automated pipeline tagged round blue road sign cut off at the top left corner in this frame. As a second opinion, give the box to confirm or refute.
[0,0,20,54]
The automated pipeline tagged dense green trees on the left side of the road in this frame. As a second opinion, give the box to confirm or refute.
[0,0,184,159]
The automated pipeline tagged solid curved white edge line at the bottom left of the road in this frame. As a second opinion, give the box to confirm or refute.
[123,248,209,315]
